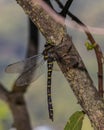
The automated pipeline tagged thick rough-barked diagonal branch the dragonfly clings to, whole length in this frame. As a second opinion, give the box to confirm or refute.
[16,0,104,130]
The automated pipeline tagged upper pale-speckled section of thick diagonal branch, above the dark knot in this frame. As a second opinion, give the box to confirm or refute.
[16,0,65,45]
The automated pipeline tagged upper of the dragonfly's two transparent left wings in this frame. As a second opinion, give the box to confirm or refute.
[5,54,43,73]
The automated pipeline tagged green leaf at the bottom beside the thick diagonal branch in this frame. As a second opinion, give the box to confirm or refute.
[64,111,85,130]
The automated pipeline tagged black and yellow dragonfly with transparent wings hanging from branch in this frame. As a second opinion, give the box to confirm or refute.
[5,44,58,121]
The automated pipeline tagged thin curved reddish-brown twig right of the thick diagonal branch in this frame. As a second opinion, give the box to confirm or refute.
[56,0,104,97]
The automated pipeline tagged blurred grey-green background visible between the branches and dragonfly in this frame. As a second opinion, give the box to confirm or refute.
[0,0,104,130]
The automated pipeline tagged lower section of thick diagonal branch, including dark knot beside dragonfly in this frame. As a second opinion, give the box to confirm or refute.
[57,36,104,130]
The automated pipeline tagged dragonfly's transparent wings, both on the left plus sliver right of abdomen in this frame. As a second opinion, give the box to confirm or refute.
[5,54,59,86]
